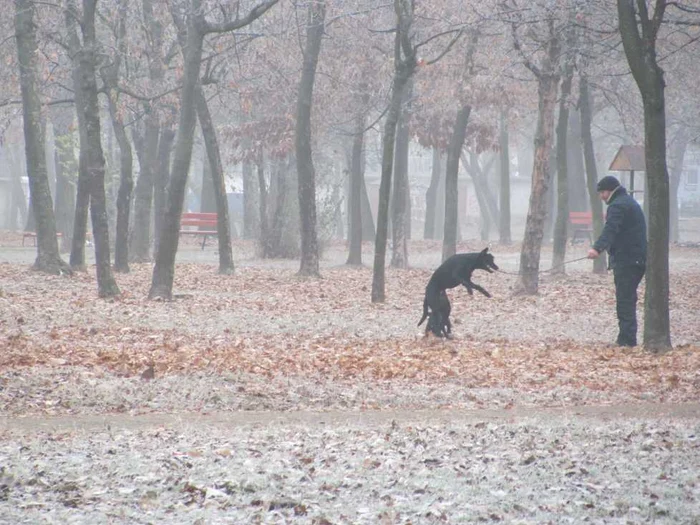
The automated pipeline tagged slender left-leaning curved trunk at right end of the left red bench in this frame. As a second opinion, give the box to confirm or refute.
[195,85,234,275]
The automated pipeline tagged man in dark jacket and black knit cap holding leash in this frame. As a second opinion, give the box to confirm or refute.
[588,175,647,346]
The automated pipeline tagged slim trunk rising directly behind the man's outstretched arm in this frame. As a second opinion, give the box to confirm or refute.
[578,79,607,274]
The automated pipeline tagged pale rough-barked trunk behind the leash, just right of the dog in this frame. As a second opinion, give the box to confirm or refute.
[514,69,559,295]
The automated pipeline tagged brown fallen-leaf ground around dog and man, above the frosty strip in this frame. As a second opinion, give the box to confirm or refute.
[0,242,700,406]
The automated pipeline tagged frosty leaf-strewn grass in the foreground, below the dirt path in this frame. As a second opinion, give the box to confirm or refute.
[0,414,700,524]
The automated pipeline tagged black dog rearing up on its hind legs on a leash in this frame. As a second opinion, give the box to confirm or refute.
[418,248,498,337]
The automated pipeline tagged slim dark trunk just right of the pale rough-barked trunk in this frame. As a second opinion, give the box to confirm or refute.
[552,64,574,274]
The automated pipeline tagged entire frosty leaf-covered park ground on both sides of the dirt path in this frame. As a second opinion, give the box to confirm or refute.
[0,238,700,523]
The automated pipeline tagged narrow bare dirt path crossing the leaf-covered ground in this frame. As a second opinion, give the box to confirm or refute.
[0,403,700,433]
